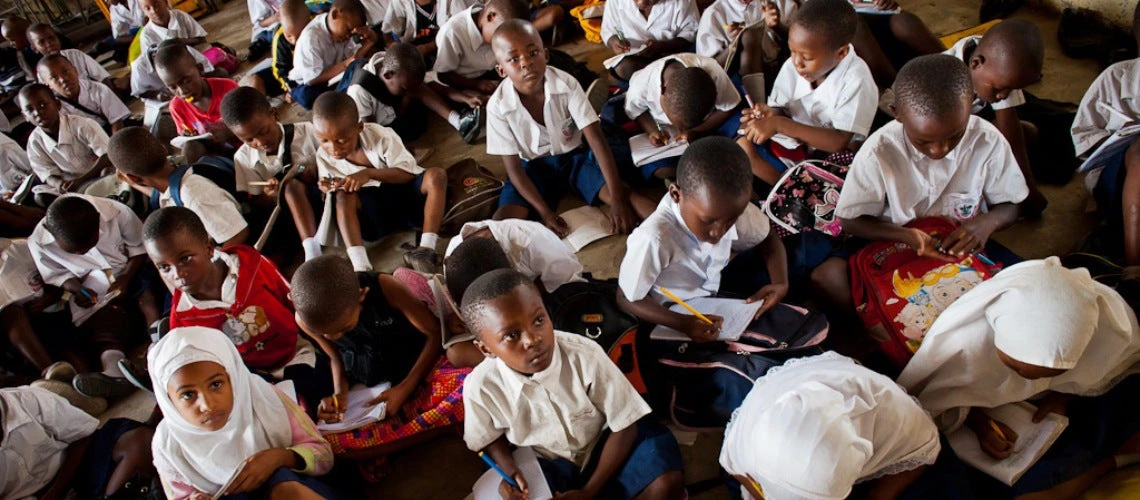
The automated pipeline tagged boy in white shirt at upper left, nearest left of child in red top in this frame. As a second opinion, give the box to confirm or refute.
[36,54,131,133]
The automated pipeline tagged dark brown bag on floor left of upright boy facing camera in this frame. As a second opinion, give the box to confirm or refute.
[439,158,503,238]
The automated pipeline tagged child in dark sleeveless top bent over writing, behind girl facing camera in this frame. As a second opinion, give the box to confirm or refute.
[292,255,441,423]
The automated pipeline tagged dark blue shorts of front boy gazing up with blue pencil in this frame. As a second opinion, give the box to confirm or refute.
[538,417,684,499]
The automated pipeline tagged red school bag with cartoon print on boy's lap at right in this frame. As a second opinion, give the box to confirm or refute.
[850,218,1001,368]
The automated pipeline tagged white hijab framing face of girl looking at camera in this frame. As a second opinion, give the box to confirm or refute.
[147,327,293,494]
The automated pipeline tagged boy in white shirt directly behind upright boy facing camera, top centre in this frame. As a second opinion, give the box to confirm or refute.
[435,0,530,99]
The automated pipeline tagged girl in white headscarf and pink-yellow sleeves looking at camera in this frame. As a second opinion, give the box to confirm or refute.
[147,327,333,499]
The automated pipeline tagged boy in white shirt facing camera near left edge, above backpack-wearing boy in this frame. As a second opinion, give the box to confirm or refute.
[19,83,111,197]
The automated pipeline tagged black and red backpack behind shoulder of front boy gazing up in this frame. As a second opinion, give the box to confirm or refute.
[544,278,646,394]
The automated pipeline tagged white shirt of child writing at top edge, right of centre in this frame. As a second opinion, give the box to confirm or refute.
[602,0,700,48]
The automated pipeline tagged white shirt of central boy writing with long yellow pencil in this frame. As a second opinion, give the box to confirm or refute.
[618,195,768,303]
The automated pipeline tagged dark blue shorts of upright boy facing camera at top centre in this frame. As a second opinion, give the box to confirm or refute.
[499,146,605,211]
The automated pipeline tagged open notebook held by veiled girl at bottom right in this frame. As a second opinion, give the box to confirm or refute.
[946,402,1068,485]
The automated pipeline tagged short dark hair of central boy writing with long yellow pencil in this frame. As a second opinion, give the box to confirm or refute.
[677,136,752,197]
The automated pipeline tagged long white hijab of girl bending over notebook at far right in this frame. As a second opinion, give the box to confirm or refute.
[898,257,1140,432]
